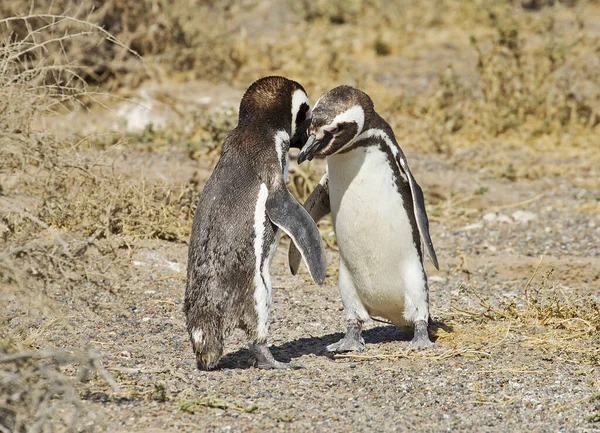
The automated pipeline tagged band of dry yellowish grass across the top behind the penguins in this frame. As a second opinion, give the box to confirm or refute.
[0,0,600,164]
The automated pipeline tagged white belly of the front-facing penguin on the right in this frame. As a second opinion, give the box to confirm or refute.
[327,147,426,324]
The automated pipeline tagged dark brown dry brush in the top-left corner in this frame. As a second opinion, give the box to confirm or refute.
[0,0,255,89]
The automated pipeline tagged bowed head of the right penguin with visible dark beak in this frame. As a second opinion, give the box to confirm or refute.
[298,86,374,163]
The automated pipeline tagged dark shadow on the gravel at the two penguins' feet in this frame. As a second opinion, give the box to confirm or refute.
[216,322,452,370]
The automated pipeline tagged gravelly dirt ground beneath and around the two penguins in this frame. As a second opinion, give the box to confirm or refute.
[1,77,600,432]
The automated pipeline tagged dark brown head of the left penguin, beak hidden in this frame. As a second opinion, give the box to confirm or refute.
[239,76,311,149]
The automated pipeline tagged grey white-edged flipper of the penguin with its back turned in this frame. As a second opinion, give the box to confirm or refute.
[267,183,327,285]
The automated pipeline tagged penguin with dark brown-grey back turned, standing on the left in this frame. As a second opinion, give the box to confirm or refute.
[183,77,327,370]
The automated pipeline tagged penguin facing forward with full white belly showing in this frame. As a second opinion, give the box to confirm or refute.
[288,86,439,352]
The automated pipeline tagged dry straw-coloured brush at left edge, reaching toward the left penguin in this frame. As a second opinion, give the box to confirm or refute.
[0,12,206,294]
